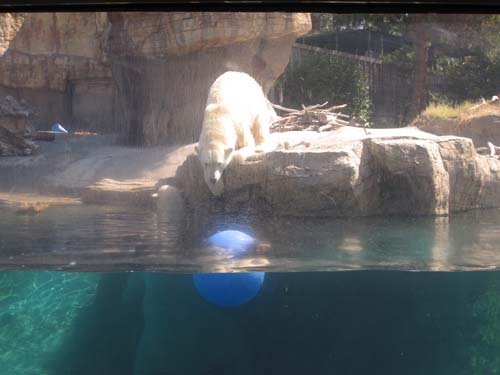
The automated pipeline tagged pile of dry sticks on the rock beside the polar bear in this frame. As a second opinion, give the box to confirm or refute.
[270,102,368,132]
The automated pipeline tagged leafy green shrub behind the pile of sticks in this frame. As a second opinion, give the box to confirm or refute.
[276,55,372,121]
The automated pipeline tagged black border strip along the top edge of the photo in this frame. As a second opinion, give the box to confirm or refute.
[0,0,500,13]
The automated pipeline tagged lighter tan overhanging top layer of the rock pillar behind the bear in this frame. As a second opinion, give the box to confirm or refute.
[108,12,311,58]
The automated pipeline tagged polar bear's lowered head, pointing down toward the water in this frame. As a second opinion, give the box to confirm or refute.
[195,143,234,195]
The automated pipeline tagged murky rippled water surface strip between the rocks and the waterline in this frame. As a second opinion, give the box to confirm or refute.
[0,205,500,272]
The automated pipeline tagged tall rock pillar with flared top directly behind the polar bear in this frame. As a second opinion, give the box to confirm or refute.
[109,13,311,145]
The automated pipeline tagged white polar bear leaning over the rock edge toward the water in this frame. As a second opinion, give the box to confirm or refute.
[196,72,276,196]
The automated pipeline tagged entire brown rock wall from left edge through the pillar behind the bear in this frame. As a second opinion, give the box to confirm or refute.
[0,12,311,145]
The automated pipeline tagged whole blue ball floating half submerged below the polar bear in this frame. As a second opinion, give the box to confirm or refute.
[193,230,265,307]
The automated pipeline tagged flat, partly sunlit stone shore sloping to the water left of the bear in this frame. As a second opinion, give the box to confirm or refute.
[0,133,193,207]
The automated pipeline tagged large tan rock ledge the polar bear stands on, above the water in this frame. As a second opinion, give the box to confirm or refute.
[176,127,500,217]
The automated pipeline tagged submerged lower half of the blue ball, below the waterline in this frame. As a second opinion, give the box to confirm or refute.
[193,272,265,307]
